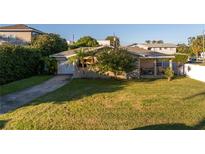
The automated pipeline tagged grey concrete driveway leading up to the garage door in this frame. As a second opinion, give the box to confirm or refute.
[0,75,71,114]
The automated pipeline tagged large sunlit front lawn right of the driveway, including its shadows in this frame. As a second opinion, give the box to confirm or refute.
[0,78,205,129]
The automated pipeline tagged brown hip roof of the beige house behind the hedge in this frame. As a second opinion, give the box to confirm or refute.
[0,24,43,33]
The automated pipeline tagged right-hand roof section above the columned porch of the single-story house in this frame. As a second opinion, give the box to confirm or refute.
[126,47,175,58]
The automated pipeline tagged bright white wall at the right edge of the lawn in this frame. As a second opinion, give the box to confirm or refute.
[184,64,205,82]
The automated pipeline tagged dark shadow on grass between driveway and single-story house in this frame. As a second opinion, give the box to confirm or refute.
[28,79,128,105]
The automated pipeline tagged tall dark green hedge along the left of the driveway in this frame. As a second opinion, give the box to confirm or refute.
[0,45,43,85]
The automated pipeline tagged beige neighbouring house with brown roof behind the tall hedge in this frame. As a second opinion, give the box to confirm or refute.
[0,24,43,44]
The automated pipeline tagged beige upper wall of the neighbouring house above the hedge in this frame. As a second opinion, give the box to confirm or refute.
[0,32,32,42]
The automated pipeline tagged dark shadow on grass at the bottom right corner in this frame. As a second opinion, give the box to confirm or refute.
[132,119,205,130]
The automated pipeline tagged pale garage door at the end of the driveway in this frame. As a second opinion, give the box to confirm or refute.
[58,60,75,74]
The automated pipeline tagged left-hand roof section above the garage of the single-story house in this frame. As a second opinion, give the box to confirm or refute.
[50,46,105,58]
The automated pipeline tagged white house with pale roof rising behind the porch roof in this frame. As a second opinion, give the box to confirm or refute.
[131,43,177,55]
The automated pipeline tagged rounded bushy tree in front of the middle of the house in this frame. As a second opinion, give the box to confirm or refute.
[96,49,135,77]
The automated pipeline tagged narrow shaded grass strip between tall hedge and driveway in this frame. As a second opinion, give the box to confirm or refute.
[0,75,51,96]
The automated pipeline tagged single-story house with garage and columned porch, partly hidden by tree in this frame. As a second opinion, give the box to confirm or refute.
[50,46,175,78]
